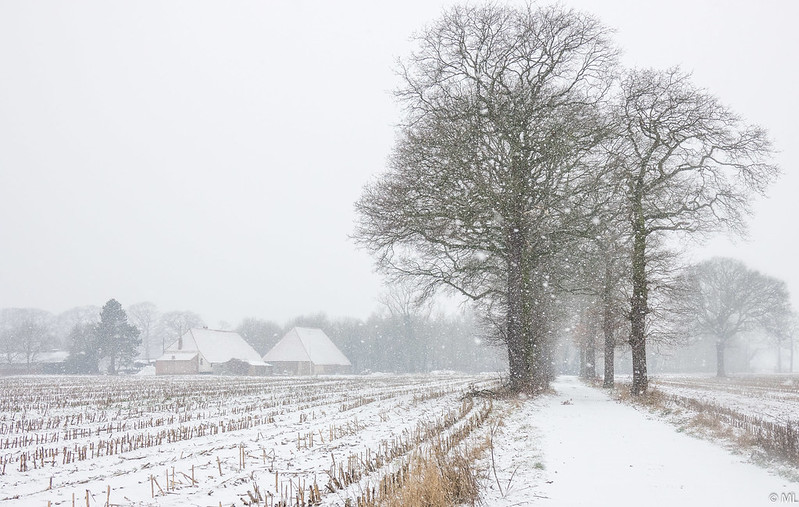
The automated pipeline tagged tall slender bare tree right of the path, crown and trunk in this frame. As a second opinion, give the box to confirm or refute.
[609,68,778,395]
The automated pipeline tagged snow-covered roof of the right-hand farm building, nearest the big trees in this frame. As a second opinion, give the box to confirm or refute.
[264,327,351,366]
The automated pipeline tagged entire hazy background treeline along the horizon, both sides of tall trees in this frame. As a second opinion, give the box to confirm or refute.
[0,258,797,378]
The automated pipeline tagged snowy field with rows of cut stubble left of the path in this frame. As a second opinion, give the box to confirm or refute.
[0,374,497,506]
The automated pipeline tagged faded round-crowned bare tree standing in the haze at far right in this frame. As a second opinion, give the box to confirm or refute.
[683,257,791,377]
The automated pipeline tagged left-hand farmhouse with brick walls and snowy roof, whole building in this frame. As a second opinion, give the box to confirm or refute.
[155,328,269,375]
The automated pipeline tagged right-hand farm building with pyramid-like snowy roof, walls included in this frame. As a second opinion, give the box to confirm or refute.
[264,327,352,375]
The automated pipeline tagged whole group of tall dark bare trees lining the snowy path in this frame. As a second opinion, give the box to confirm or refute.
[355,4,778,395]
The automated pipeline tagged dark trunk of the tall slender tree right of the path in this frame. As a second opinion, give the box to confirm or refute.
[630,210,649,396]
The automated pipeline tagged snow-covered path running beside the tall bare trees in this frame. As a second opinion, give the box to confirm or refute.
[486,377,799,507]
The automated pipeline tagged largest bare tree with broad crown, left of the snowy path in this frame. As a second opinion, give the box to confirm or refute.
[355,4,616,392]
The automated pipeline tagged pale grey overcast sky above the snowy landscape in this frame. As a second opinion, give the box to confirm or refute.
[0,0,799,326]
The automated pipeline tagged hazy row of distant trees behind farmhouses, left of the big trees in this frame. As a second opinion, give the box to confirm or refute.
[0,296,504,374]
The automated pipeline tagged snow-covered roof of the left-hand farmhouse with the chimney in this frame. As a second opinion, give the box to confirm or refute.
[159,328,264,365]
